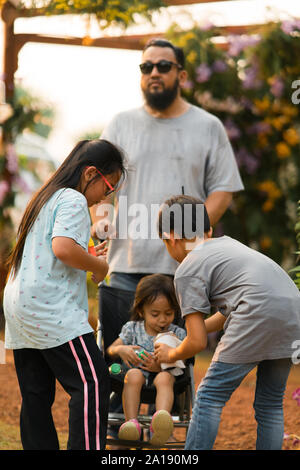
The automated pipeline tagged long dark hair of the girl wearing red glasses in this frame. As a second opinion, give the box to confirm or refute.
[6,139,126,280]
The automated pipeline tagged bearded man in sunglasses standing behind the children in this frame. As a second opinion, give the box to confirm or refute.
[92,39,244,438]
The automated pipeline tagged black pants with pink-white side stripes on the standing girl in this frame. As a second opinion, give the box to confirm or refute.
[14,333,110,450]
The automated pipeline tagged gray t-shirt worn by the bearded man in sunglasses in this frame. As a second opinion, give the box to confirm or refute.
[101,106,244,274]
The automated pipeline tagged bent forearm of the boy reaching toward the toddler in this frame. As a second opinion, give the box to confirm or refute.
[155,312,207,363]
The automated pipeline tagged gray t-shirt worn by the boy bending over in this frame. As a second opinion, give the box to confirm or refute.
[174,236,300,363]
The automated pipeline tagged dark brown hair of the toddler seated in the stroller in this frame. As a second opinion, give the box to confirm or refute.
[131,274,180,321]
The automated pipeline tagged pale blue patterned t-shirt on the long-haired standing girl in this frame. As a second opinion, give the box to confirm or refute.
[4,188,93,349]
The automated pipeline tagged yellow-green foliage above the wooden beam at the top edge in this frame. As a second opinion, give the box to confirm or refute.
[21,0,166,27]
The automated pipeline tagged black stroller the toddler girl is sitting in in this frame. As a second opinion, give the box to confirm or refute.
[97,284,195,449]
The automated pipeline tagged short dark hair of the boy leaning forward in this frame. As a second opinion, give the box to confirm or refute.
[157,195,210,239]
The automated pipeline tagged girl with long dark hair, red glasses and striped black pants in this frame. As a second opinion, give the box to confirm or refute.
[4,140,126,450]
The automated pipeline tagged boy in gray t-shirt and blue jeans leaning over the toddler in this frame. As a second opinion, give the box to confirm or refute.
[155,196,300,450]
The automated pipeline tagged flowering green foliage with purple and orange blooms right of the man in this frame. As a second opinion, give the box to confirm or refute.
[168,20,300,264]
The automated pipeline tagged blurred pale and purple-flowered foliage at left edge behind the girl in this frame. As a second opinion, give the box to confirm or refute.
[0,88,55,307]
